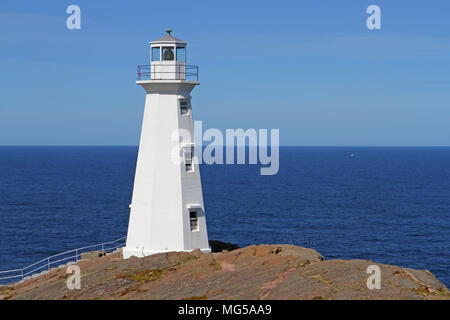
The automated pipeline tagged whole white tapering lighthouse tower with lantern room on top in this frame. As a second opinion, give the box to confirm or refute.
[123,30,210,259]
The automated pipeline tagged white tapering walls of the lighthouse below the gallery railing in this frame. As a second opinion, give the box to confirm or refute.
[123,80,210,258]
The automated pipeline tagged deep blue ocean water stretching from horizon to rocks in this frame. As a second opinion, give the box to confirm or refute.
[0,147,450,286]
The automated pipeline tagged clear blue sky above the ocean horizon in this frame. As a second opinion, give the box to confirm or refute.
[0,0,450,146]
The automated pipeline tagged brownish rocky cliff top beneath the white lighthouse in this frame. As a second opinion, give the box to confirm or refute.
[0,243,450,300]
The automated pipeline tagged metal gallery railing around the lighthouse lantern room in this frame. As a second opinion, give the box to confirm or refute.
[137,64,198,81]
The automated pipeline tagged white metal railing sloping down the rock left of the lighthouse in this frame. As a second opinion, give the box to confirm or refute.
[0,237,126,284]
